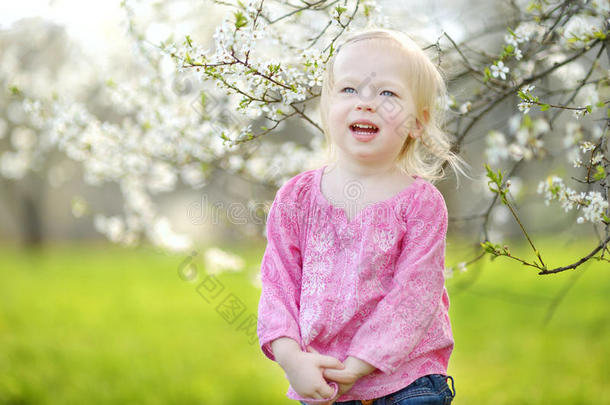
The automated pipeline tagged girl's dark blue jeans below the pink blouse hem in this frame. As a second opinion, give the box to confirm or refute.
[299,374,455,405]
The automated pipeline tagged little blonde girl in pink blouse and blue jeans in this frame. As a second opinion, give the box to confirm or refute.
[257,26,463,405]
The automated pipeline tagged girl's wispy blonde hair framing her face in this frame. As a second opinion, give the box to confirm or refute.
[320,29,469,182]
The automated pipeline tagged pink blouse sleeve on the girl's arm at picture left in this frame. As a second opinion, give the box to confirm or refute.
[257,182,302,361]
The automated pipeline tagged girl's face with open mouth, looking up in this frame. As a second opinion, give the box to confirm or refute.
[328,39,422,165]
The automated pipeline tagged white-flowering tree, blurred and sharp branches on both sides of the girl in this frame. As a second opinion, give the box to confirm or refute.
[3,0,610,274]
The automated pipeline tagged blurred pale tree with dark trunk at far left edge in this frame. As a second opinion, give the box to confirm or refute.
[0,18,94,245]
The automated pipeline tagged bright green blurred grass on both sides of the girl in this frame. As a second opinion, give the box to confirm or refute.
[0,240,610,405]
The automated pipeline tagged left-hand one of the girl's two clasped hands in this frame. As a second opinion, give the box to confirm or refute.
[284,350,345,405]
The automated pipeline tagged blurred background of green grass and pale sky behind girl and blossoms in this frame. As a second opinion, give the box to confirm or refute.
[0,0,610,405]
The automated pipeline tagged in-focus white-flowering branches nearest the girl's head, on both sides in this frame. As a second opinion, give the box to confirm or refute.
[169,1,610,274]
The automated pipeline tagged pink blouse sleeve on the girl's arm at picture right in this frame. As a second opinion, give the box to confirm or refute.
[347,185,448,374]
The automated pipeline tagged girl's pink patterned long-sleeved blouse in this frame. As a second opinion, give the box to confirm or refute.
[257,166,454,403]
